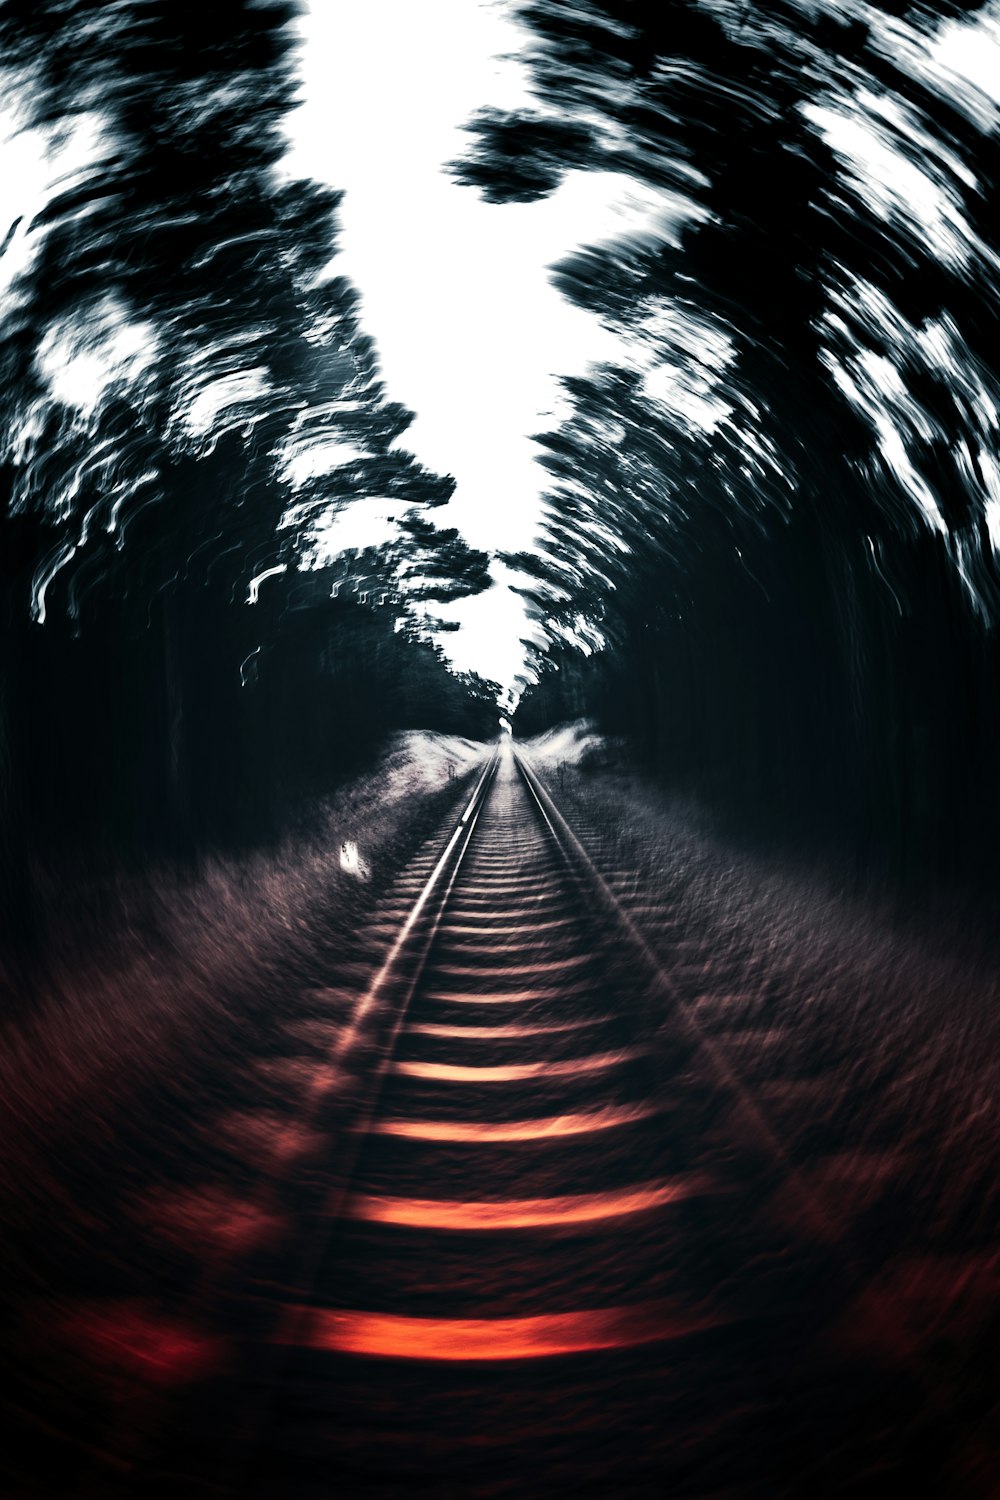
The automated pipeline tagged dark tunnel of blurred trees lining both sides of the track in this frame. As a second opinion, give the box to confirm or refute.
[0,0,1000,996]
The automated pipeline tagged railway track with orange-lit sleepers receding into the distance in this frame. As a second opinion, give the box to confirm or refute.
[132,747,961,1500]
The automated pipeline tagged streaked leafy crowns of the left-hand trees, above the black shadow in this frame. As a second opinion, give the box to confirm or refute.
[0,0,485,618]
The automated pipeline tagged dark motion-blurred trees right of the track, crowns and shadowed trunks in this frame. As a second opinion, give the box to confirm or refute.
[464,0,1000,884]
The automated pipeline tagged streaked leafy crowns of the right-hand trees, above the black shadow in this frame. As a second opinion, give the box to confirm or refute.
[456,0,1000,675]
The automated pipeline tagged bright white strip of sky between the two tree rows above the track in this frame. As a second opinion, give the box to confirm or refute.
[288,0,663,684]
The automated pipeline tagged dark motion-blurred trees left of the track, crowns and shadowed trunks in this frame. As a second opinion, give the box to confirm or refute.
[0,0,486,978]
